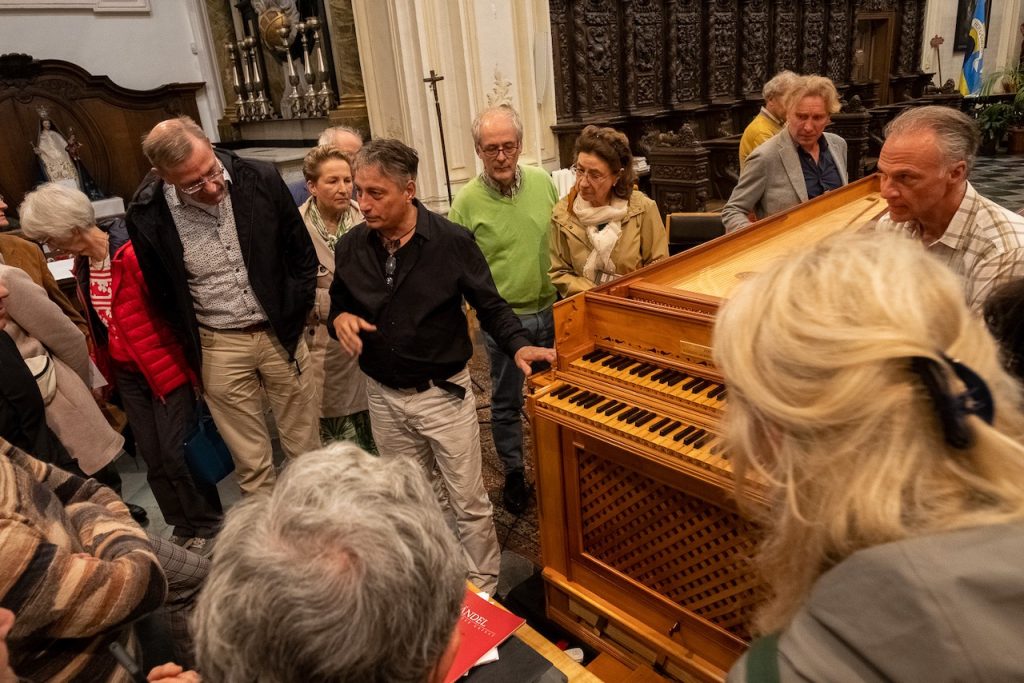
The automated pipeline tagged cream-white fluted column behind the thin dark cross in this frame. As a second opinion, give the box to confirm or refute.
[352,0,558,212]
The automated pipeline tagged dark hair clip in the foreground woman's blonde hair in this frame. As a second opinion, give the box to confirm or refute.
[910,353,995,450]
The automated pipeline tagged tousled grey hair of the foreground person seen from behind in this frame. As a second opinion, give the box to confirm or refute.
[193,443,466,683]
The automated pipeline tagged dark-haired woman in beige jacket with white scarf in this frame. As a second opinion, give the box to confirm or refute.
[548,126,669,297]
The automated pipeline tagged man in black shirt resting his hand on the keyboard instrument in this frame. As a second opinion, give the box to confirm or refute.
[331,139,555,593]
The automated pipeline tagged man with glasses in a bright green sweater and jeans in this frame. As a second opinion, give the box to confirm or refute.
[449,104,558,514]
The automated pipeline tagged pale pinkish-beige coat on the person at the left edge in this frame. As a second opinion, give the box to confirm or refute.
[0,265,125,474]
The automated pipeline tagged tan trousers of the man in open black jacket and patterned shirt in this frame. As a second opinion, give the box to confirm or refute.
[199,328,321,496]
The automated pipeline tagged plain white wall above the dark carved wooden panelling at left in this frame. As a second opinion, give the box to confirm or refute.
[0,0,223,140]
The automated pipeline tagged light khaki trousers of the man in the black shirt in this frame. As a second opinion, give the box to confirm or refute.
[367,370,501,595]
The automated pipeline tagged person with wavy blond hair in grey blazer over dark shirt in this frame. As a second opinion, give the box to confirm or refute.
[722,76,848,232]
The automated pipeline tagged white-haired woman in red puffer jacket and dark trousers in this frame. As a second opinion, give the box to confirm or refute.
[20,183,223,553]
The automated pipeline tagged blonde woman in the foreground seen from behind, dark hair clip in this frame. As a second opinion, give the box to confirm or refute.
[714,234,1024,682]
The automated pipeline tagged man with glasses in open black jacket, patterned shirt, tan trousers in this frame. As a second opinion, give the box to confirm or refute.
[127,117,319,495]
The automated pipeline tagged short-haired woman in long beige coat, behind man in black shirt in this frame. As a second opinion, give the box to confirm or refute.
[299,146,376,453]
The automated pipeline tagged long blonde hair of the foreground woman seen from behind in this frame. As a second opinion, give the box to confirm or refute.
[714,232,1024,633]
